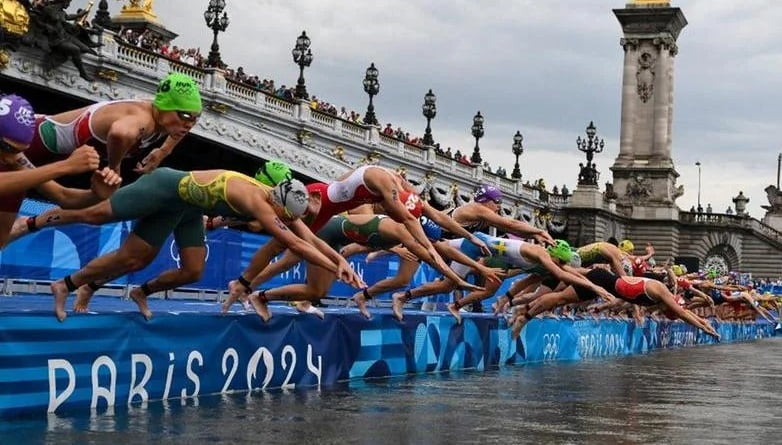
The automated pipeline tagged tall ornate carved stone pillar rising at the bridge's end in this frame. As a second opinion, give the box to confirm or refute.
[611,1,687,219]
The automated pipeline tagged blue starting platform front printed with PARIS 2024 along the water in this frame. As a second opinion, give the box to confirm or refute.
[0,295,774,417]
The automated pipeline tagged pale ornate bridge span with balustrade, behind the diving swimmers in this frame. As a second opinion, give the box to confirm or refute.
[0,31,567,232]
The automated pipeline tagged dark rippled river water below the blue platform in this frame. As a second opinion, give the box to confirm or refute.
[0,338,782,445]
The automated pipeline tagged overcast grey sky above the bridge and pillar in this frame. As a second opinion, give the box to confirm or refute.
[73,0,782,218]
